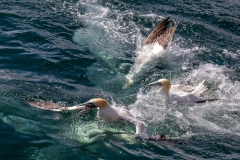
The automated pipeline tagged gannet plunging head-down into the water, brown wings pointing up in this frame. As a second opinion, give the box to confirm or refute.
[123,17,178,88]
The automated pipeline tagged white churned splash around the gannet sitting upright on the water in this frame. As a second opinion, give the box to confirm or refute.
[129,63,240,137]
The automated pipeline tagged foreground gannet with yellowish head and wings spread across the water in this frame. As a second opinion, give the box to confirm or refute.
[27,98,150,139]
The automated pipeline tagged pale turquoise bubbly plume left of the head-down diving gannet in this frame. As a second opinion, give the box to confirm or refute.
[73,2,138,92]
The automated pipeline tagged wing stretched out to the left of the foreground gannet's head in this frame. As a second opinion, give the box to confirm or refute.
[26,99,89,111]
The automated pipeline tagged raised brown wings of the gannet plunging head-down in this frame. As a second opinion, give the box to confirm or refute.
[145,17,178,48]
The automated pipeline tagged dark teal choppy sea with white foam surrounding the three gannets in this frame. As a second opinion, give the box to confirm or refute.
[0,0,240,160]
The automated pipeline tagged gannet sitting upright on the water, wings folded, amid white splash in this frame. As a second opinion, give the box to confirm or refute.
[147,79,217,103]
